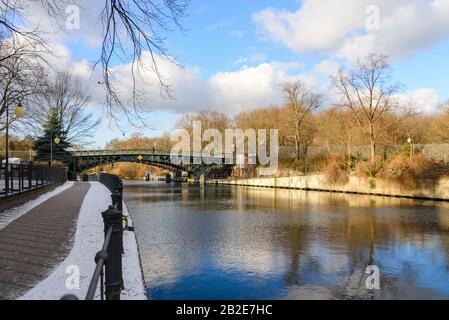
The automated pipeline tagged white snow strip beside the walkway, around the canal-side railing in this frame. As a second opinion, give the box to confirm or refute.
[20,182,146,300]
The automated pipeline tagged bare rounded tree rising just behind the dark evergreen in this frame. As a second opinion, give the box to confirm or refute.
[29,71,100,145]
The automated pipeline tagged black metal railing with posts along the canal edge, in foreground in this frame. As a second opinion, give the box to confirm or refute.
[62,173,123,300]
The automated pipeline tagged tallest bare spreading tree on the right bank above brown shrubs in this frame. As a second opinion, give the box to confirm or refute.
[332,54,411,162]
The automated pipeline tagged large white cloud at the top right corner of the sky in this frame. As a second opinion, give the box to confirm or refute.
[253,0,449,59]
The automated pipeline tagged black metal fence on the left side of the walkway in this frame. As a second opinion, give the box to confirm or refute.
[0,163,67,198]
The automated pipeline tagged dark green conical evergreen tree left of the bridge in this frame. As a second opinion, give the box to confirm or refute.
[34,109,71,163]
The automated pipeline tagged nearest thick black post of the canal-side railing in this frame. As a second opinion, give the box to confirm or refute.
[101,206,123,300]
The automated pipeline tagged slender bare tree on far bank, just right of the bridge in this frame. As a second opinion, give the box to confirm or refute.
[283,81,322,159]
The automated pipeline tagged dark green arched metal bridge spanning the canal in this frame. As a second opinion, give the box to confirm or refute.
[70,149,233,179]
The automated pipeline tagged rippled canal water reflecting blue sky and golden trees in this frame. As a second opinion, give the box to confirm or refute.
[125,182,449,299]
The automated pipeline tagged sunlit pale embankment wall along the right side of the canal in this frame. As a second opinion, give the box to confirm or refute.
[206,175,449,201]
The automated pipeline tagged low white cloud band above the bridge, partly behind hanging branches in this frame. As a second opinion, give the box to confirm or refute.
[53,49,312,115]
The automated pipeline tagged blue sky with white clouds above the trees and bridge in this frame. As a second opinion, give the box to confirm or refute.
[51,0,449,147]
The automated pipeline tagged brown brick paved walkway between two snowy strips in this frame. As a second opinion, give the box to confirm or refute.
[0,183,90,299]
